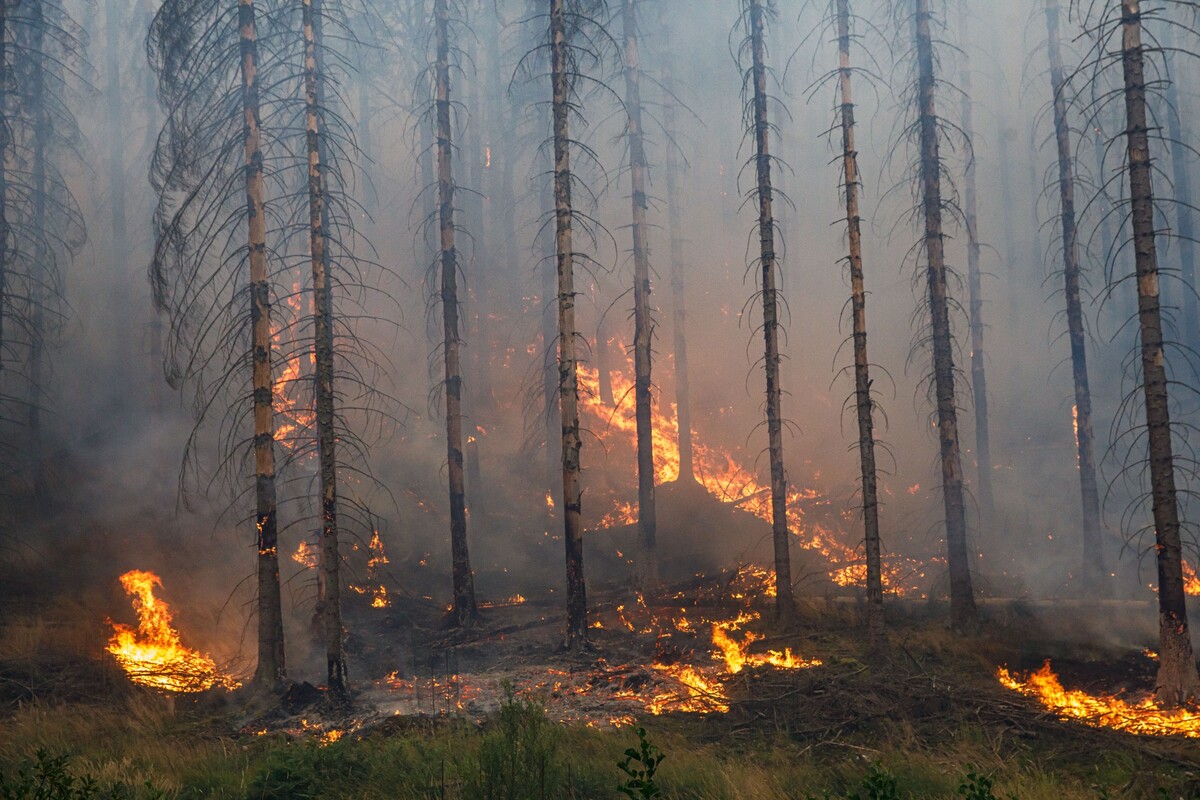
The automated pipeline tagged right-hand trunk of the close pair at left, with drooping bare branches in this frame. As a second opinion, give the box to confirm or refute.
[302,0,347,696]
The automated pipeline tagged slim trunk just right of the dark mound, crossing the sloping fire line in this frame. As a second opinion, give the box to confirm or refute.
[748,0,796,621]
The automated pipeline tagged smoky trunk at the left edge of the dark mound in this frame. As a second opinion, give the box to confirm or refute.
[622,0,659,590]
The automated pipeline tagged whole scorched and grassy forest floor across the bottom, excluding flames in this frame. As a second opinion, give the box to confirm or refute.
[0,582,1200,800]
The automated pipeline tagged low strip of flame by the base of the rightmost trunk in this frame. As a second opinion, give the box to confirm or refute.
[996,661,1200,738]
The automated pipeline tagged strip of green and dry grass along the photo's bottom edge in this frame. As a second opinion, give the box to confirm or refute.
[0,698,1200,800]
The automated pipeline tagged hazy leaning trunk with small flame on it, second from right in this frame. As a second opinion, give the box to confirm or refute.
[1045,0,1105,593]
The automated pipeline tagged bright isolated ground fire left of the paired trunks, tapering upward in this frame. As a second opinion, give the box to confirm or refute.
[107,570,241,692]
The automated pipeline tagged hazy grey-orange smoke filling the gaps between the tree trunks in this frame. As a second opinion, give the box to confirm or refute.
[5,0,1194,686]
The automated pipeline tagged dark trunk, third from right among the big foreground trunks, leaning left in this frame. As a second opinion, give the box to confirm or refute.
[914,0,978,633]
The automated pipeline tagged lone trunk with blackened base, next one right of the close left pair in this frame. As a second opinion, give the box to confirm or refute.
[433,0,479,625]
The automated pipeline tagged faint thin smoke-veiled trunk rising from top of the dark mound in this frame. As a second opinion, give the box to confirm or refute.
[662,54,696,483]
